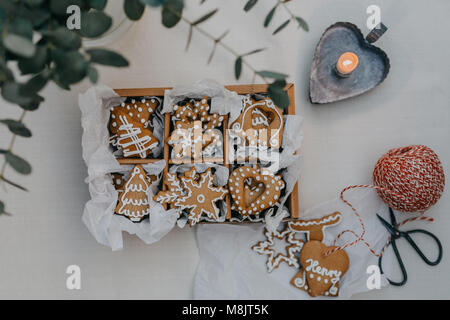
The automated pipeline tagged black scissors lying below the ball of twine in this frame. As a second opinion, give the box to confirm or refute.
[377,208,442,286]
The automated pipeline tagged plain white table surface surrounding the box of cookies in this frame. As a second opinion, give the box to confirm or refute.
[0,0,450,299]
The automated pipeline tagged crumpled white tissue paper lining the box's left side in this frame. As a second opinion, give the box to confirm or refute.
[79,86,178,250]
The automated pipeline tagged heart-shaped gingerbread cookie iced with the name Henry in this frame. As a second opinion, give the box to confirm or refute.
[291,240,349,297]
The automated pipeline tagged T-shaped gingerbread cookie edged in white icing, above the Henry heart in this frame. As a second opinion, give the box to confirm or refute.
[289,211,342,241]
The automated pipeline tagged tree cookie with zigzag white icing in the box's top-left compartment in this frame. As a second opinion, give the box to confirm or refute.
[115,109,159,158]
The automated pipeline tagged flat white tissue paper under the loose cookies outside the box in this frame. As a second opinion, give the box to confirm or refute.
[194,189,394,299]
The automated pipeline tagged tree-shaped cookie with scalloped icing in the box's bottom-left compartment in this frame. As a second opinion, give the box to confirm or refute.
[115,164,150,222]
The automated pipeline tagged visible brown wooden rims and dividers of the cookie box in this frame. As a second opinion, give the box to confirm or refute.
[114,83,299,223]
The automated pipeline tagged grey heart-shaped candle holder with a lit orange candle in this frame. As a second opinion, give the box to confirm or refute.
[309,22,390,104]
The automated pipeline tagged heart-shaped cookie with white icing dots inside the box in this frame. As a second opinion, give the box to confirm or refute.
[228,166,284,216]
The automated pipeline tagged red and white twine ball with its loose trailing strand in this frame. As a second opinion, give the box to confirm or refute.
[326,145,445,257]
